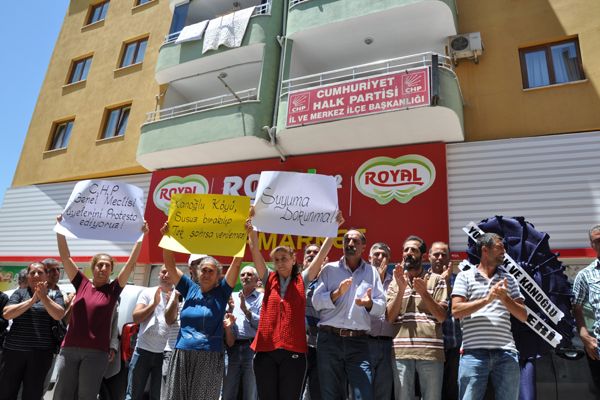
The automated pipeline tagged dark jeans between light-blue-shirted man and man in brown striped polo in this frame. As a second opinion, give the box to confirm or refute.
[369,337,394,400]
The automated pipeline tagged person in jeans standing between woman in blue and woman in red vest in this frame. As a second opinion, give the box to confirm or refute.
[223,266,263,400]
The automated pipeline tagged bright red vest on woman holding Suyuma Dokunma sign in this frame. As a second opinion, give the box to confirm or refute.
[250,272,308,353]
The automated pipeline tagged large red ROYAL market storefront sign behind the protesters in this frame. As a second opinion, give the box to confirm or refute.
[140,143,448,263]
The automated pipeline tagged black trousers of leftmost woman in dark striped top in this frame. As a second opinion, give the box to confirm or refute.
[0,349,54,400]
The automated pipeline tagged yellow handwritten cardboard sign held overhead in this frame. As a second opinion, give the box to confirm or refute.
[159,194,250,257]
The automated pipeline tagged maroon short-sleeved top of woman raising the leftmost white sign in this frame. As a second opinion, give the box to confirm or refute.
[63,272,123,353]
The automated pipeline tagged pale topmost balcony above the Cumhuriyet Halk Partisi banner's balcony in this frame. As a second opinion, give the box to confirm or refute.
[286,0,458,50]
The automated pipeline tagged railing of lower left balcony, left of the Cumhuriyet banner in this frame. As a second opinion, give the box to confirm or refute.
[146,88,258,123]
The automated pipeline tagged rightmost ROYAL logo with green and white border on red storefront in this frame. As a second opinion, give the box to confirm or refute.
[354,154,435,205]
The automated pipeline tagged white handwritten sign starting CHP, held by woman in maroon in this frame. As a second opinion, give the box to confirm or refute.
[54,180,144,243]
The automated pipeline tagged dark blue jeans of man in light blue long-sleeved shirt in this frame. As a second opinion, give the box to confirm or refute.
[317,331,374,400]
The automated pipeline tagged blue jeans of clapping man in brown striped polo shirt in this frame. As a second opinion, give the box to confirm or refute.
[396,359,444,400]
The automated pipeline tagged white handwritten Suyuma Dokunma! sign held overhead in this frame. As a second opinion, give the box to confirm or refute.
[252,171,338,237]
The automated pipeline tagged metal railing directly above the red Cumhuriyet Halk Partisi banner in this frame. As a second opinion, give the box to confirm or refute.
[281,52,454,96]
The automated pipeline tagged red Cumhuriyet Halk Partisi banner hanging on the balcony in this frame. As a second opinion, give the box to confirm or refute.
[287,67,431,128]
